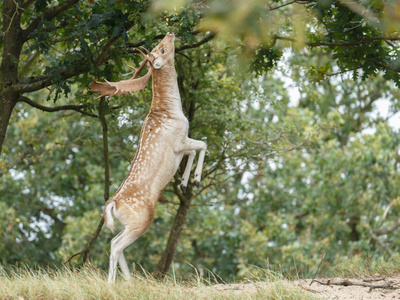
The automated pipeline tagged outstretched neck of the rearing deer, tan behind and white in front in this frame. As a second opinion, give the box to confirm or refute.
[151,64,183,115]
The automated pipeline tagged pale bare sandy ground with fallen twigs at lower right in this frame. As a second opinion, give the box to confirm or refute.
[213,276,400,300]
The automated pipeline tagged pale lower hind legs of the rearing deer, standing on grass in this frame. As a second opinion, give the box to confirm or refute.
[108,229,139,283]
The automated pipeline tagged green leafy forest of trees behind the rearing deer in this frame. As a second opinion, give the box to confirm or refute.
[0,0,400,280]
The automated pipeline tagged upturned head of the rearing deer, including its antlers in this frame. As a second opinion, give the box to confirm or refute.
[91,32,175,98]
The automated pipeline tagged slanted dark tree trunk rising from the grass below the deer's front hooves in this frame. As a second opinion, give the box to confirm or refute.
[155,186,192,278]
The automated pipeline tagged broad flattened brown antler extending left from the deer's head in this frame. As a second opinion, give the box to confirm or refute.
[91,67,152,98]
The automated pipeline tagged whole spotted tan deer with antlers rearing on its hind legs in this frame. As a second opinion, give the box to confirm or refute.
[92,32,207,283]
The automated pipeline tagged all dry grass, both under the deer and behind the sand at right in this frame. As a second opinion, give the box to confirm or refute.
[0,255,400,300]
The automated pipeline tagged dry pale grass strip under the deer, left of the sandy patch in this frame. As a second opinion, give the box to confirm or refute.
[0,268,319,300]
